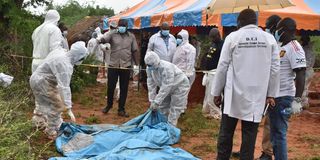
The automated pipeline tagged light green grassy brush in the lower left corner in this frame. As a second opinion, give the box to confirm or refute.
[0,80,57,160]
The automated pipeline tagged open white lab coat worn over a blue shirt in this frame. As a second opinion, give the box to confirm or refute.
[148,31,177,62]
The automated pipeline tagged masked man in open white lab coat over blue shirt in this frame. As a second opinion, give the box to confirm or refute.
[148,22,177,62]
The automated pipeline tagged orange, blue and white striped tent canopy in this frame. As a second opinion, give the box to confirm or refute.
[109,0,320,30]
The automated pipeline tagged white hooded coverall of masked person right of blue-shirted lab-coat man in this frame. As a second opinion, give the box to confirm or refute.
[172,29,196,86]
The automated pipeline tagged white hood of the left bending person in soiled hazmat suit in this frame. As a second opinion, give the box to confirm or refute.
[68,41,88,65]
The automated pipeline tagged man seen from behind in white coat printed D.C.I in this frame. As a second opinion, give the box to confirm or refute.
[212,9,280,160]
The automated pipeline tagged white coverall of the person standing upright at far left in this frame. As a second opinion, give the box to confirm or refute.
[32,10,63,72]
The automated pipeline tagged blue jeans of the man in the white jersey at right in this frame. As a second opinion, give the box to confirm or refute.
[269,96,294,160]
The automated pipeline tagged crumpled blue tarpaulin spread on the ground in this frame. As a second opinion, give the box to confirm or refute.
[50,110,198,160]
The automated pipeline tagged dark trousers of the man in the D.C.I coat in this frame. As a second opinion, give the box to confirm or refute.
[217,114,259,160]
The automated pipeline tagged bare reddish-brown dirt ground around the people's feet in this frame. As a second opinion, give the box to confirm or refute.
[68,72,320,160]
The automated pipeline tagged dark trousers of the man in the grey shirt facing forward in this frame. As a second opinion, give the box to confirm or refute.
[107,67,131,112]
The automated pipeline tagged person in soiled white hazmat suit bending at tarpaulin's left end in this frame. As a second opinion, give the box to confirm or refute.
[30,41,87,139]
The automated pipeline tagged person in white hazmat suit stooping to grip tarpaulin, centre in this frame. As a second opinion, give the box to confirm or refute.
[144,51,190,126]
